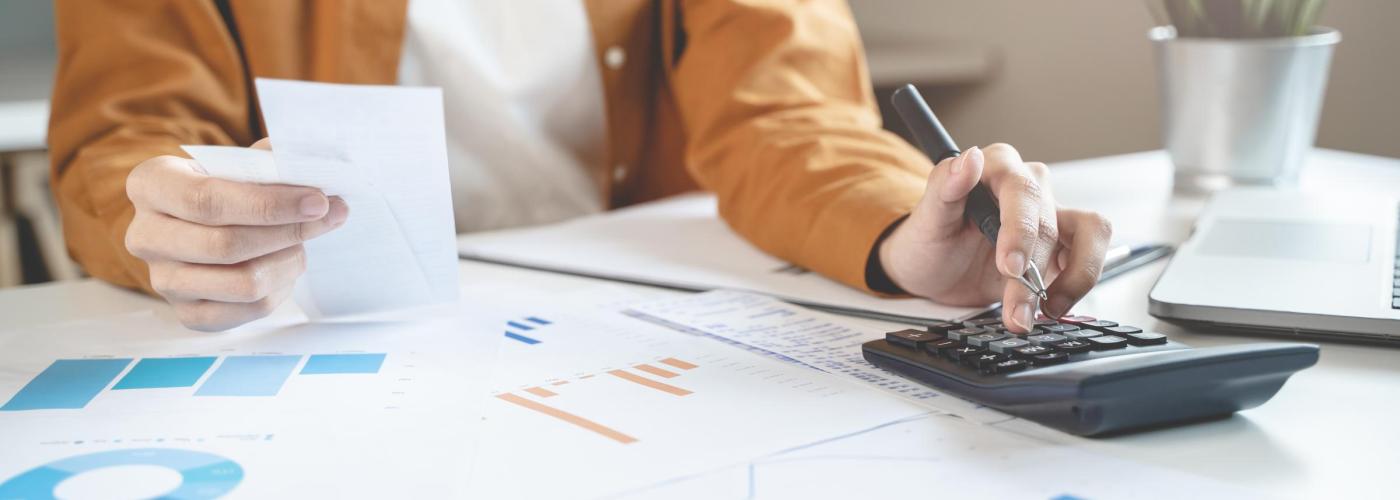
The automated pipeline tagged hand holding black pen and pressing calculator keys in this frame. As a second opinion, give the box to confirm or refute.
[878,144,1113,332]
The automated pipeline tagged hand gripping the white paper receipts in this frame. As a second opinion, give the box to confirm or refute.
[126,140,350,331]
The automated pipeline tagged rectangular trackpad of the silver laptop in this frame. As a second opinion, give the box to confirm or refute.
[1200,218,1371,263]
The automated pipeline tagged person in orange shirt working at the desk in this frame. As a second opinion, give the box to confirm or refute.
[49,0,1110,332]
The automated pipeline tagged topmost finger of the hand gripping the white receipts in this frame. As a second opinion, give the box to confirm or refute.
[127,157,329,225]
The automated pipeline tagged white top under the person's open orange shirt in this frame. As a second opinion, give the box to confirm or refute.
[399,0,608,232]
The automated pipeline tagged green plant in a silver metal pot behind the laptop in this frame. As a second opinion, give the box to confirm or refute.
[1148,0,1341,192]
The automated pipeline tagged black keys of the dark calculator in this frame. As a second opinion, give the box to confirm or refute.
[885,315,1168,375]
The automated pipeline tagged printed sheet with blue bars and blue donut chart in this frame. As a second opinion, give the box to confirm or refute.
[0,310,500,499]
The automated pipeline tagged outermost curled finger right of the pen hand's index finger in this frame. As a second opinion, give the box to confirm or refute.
[1044,210,1113,318]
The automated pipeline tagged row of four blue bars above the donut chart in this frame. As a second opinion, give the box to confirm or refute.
[0,353,388,412]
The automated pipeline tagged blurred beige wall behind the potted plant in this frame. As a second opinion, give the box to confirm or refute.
[851,0,1400,161]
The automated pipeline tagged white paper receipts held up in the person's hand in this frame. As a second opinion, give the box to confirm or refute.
[183,78,458,318]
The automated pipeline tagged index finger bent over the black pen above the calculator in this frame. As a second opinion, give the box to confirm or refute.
[983,144,1049,277]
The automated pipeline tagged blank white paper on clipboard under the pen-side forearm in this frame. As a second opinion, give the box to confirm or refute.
[458,190,979,324]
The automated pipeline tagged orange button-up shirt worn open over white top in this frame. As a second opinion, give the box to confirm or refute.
[49,0,932,291]
